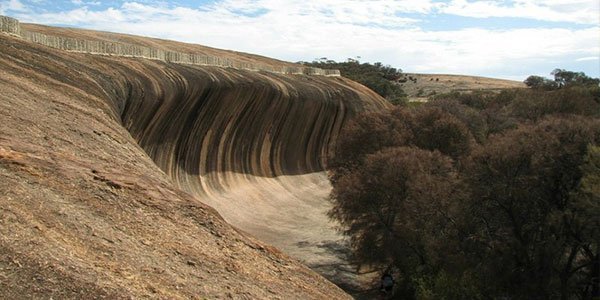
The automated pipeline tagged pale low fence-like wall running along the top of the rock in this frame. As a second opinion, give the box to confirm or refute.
[0,16,340,76]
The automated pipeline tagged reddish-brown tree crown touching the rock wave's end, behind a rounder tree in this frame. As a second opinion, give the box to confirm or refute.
[328,105,474,173]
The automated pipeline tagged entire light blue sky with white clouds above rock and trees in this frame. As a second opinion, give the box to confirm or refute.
[0,0,600,81]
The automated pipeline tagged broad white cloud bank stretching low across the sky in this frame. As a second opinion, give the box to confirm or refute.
[8,0,600,78]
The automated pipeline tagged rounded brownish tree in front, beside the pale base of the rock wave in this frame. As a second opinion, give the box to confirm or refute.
[330,147,456,284]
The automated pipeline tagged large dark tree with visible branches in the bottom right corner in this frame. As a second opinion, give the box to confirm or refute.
[462,117,600,299]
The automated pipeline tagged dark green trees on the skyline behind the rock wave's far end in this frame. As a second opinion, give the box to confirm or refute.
[301,60,407,105]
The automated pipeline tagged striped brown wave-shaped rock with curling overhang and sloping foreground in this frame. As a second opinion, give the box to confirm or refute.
[0,17,387,299]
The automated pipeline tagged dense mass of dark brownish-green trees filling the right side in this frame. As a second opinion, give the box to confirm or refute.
[330,77,600,299]
